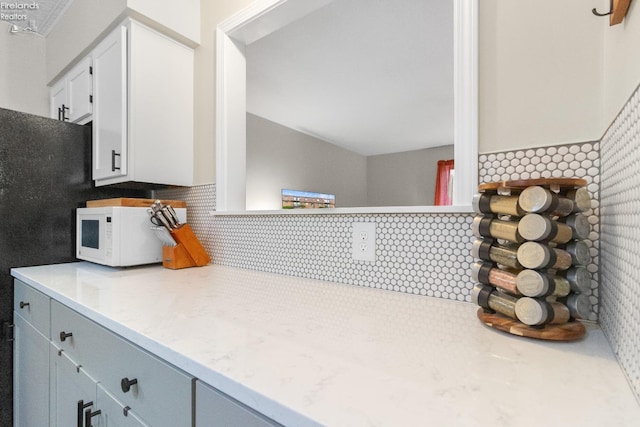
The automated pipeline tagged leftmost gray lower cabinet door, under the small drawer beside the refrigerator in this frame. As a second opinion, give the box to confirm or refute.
[13,313,49,427]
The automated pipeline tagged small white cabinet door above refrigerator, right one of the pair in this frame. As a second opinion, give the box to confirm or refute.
[65,57,93,123]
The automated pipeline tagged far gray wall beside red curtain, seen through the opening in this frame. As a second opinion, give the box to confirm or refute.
[367,145,453,206]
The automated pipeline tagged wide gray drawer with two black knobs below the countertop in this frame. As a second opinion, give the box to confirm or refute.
[51,301,193,426]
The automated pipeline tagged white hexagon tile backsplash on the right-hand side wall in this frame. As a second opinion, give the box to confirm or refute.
[599,89,640,400]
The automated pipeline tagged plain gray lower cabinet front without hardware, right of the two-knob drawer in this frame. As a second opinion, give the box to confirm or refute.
[196,380,280,427]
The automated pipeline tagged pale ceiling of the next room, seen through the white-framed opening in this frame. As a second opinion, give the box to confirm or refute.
[245,0,453,156]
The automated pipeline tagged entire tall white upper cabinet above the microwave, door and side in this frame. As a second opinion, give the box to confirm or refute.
[93,20,194,186]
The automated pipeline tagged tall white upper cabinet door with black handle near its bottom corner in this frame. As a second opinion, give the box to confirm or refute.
[92,26,128,180]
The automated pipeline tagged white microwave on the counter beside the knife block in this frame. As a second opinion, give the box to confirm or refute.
[76,206,187,267]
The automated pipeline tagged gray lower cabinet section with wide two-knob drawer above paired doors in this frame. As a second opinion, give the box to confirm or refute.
[51,300,194,427]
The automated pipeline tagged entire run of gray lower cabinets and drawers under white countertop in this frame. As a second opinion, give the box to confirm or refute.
[14,280,280,427]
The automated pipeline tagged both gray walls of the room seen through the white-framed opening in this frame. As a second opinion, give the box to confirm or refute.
[247,113,453,210]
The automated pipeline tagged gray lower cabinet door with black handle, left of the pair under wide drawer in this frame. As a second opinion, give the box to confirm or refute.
[50,343,97,427]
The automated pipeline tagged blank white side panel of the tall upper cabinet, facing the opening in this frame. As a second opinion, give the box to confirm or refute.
[129,21,194,186]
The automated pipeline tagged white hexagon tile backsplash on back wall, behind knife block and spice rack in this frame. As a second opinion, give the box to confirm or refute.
[158,142,599,320]
